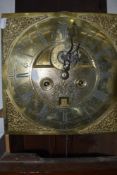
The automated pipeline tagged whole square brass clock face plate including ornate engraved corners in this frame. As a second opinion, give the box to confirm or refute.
[3,13,117,134]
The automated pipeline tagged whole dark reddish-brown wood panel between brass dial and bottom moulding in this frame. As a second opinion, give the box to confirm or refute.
[10,133,117,157]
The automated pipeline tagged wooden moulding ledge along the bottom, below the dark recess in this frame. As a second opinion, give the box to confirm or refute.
[0,153,117,175]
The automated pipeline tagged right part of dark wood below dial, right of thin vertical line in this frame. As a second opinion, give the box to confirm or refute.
[69,133,117,156]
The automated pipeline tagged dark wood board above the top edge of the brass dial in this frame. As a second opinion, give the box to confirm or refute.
[16,0,107,12]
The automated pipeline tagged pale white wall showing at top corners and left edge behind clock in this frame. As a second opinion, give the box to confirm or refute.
[0,0,117,136]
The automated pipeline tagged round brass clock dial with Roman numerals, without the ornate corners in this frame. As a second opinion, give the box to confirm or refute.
[4,15,117,132]
